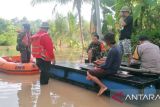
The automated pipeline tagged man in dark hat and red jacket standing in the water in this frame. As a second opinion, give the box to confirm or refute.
[32,22,55,85]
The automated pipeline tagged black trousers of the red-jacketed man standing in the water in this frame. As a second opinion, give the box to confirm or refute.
[36,58,51,84]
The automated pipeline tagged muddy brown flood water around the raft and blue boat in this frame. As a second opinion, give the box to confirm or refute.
[0,46,160,107]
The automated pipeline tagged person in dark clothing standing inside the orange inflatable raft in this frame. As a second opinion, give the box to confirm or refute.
[16,24,31,63]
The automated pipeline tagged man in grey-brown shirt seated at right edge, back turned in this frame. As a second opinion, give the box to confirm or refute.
[133,36,160,71]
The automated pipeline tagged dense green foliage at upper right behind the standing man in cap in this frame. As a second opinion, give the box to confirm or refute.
[101,0,160,48]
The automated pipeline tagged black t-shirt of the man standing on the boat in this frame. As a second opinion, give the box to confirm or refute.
[120,16,133,40]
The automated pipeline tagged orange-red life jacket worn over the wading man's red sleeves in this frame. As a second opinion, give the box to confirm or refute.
[31,33,51,61]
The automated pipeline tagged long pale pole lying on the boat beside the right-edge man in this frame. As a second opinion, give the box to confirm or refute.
[120,66,160,75]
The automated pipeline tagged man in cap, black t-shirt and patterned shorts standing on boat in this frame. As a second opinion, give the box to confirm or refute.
[119,6,133,65]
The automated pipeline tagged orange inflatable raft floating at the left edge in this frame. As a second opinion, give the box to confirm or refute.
[0,56,39,75]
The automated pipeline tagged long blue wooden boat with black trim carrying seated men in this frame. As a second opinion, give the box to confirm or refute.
[50,63,160,95]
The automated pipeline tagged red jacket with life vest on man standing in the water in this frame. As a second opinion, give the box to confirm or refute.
[31,30,55,61]
